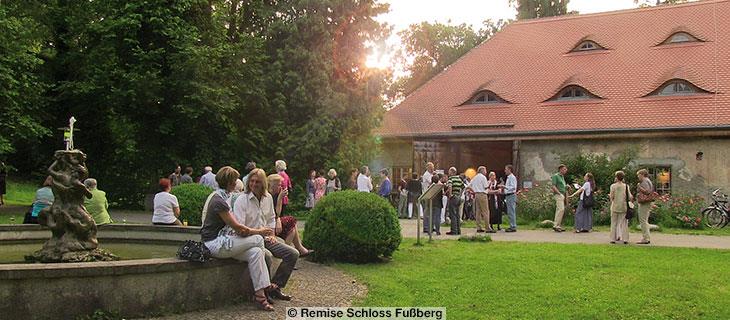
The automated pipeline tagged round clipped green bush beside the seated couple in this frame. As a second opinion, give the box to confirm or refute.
[304,191,402,263]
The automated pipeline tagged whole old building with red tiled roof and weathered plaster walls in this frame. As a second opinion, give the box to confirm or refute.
[377,0,730,196]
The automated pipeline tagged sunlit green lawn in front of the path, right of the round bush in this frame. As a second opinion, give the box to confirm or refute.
[337,240,730,319]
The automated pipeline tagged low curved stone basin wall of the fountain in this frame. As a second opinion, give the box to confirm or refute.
[0,225,276,319]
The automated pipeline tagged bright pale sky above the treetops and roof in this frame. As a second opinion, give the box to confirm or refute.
[367,0,637,68]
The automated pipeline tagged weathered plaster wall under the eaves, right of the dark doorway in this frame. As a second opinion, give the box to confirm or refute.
[520,138,730,197]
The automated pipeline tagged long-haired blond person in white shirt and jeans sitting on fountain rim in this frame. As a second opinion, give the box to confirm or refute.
[232,169,299,301]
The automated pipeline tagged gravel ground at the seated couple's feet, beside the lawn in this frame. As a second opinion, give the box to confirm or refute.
[146,260,367,320]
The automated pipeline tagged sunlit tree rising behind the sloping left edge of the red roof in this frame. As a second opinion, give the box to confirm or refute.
[387,20,509,101]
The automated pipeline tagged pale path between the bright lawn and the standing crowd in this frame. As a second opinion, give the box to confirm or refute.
[400,219,730,249]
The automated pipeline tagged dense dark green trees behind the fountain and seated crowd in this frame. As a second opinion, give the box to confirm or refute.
[0,0,389,207]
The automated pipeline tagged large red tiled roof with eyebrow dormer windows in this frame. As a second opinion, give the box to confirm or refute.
[376,0,730,137]
